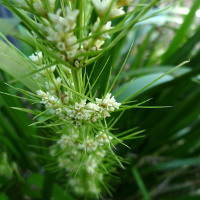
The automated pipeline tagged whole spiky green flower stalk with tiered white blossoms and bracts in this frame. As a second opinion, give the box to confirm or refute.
[0,0,173,199]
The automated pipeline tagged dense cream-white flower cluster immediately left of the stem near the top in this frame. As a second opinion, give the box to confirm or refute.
[41,7,79,60]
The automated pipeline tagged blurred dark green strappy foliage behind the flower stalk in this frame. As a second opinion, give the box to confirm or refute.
[0,0,200,200]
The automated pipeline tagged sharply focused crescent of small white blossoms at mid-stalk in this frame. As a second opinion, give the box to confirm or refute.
[37,89,121,125]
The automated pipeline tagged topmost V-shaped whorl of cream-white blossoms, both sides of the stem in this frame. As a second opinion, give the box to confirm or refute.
[15,0,132,68]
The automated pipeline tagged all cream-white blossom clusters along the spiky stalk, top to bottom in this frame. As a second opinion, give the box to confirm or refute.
[16,0,132,195]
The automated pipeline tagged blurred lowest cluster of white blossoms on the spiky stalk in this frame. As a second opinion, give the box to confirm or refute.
[51,128,113,195]
